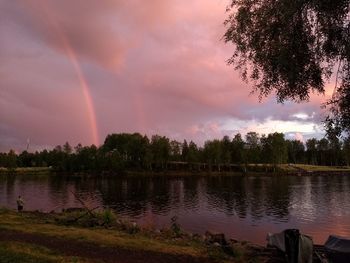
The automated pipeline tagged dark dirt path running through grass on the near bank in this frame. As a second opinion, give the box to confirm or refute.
[0,230,210,263]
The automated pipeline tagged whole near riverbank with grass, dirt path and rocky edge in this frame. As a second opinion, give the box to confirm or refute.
[0,208,274,263]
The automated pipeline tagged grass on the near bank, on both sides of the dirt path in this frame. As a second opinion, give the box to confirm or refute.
[0,208,266,262]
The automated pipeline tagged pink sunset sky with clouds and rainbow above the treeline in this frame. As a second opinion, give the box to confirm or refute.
[0,0,332,151]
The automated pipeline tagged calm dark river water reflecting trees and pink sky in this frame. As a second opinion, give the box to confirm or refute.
[0,176,350,244]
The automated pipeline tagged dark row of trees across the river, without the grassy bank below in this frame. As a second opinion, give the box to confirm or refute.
[0,132,350,172]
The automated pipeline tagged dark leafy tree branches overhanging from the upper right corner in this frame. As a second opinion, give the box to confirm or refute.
[224,0,350,134]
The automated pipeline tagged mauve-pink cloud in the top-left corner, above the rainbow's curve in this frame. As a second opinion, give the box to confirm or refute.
[2,0,127,69]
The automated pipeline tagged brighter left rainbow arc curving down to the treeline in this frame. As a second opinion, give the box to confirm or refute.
[42,1,99,146]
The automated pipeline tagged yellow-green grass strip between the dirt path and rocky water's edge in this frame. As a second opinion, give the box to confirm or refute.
[0,209,216,262]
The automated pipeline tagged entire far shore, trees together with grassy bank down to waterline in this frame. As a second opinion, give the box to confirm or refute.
[0,132,350,176]
